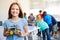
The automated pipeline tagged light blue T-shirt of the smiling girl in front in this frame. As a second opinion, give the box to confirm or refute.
[3,18,27,40]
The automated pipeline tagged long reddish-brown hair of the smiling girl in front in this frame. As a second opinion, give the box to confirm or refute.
[8,2,23,19]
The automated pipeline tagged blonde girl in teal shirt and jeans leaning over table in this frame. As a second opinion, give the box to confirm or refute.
[35,15,51,40]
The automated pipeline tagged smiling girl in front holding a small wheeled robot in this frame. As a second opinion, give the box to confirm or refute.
[3,2,28,40]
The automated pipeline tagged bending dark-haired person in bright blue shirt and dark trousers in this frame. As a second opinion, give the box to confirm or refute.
[43,11,52,33]
